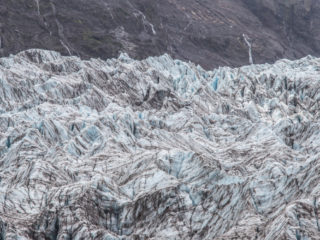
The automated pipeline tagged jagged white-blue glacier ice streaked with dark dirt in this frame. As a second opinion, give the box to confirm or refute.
[0,50,320,240]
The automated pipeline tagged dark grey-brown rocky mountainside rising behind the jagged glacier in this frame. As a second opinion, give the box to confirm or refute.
[0,0,320,69]
